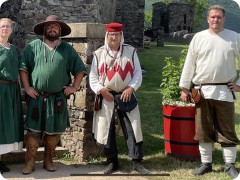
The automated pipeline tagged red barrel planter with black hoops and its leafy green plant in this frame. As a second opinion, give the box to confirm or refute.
[160,46,200,161]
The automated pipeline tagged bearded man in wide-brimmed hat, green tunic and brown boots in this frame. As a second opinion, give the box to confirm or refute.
[20,15,86,174]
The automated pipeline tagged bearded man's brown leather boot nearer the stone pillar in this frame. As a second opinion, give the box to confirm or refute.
[43,135,60,172]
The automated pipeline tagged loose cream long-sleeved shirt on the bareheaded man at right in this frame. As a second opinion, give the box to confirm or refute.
[179,29,240,102]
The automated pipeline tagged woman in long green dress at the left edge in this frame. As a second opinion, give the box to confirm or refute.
[0,18,24,177]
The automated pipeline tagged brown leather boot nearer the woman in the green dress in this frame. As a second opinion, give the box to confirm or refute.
[22,135,39,175]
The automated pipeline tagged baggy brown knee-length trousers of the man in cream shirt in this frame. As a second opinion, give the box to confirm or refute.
[194,99,240,147]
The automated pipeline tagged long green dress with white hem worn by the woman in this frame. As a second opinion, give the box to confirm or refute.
[0,45,24,148]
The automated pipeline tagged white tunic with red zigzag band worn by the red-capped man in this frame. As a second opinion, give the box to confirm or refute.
[89,38,143,145]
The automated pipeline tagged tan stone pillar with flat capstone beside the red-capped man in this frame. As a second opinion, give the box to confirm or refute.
[61,23,105,162]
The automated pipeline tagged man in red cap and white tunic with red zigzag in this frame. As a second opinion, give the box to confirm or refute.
[89,22,149,174]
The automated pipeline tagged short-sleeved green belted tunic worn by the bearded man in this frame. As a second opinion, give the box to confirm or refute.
[20,39,86,134]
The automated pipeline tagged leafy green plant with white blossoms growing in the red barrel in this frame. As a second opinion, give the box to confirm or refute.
[160,46,193,106]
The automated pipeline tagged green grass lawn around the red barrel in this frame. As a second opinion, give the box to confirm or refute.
[115,43,240,180]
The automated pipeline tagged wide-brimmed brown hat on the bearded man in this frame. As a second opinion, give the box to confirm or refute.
[33,15,71,36]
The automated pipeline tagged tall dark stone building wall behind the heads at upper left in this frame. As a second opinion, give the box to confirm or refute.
[0,0,145,51]
